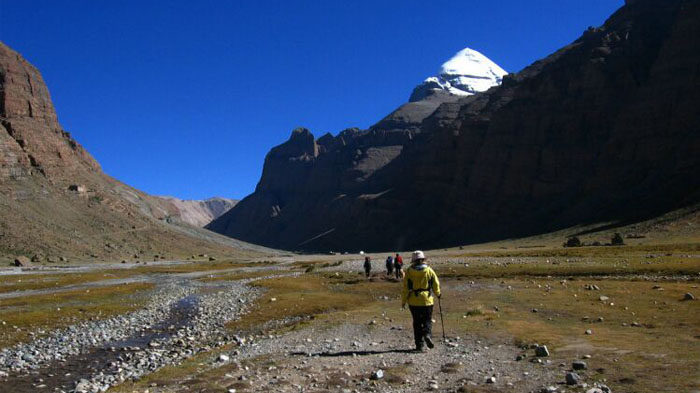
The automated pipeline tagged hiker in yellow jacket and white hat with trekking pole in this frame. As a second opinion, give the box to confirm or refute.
[401,251,440,351]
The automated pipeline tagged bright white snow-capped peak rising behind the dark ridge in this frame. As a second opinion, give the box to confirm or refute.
[410,48,507,101]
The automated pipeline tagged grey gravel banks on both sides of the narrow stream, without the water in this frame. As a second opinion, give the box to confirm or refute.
[0,277,296,393]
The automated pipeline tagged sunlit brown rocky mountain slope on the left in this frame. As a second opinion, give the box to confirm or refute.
[0,43,268,260]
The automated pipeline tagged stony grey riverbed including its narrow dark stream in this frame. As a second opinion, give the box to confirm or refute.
[0,272,294,393]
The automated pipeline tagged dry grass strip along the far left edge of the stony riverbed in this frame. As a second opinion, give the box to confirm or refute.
[0,283,153,348]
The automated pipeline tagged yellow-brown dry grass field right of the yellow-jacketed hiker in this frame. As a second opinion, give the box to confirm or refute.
[443,279,700,392]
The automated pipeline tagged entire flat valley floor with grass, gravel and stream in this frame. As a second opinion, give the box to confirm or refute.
[0,242,700,393]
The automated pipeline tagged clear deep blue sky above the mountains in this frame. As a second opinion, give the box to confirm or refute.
[0,0,623,199]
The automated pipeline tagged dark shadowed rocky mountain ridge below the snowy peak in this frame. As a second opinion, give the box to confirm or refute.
[208,0,700,251]
